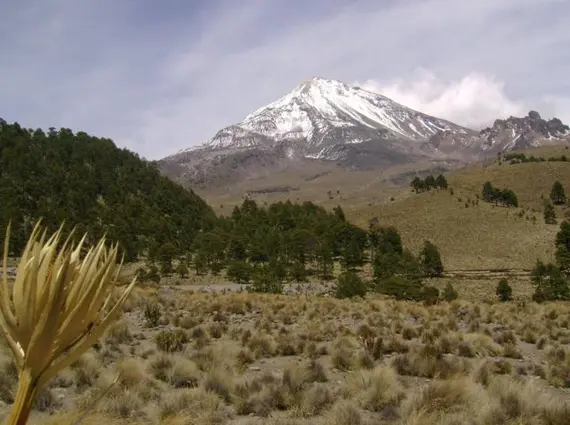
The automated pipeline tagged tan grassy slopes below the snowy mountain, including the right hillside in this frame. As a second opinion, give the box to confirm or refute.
[194,147,570,269]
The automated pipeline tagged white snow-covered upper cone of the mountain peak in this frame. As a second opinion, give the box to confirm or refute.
[197,78,466,157]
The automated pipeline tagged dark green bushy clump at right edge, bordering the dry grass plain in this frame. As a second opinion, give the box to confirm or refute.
[531,261,570,302]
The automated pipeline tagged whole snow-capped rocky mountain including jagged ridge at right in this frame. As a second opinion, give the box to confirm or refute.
[158,78,570,186]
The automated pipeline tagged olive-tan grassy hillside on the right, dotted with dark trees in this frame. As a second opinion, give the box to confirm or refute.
[345,147,570,268]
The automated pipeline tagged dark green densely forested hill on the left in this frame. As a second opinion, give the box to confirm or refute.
[0,120,215,261]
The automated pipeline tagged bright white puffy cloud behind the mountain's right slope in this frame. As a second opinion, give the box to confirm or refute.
[357,69,529,129]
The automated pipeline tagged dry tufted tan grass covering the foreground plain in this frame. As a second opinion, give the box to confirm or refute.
[0,281,570,425]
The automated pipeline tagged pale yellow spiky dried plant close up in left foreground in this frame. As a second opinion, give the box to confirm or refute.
[0,223,136,425]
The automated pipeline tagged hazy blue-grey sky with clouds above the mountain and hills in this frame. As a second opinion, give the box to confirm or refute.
[0,0,570,159]
